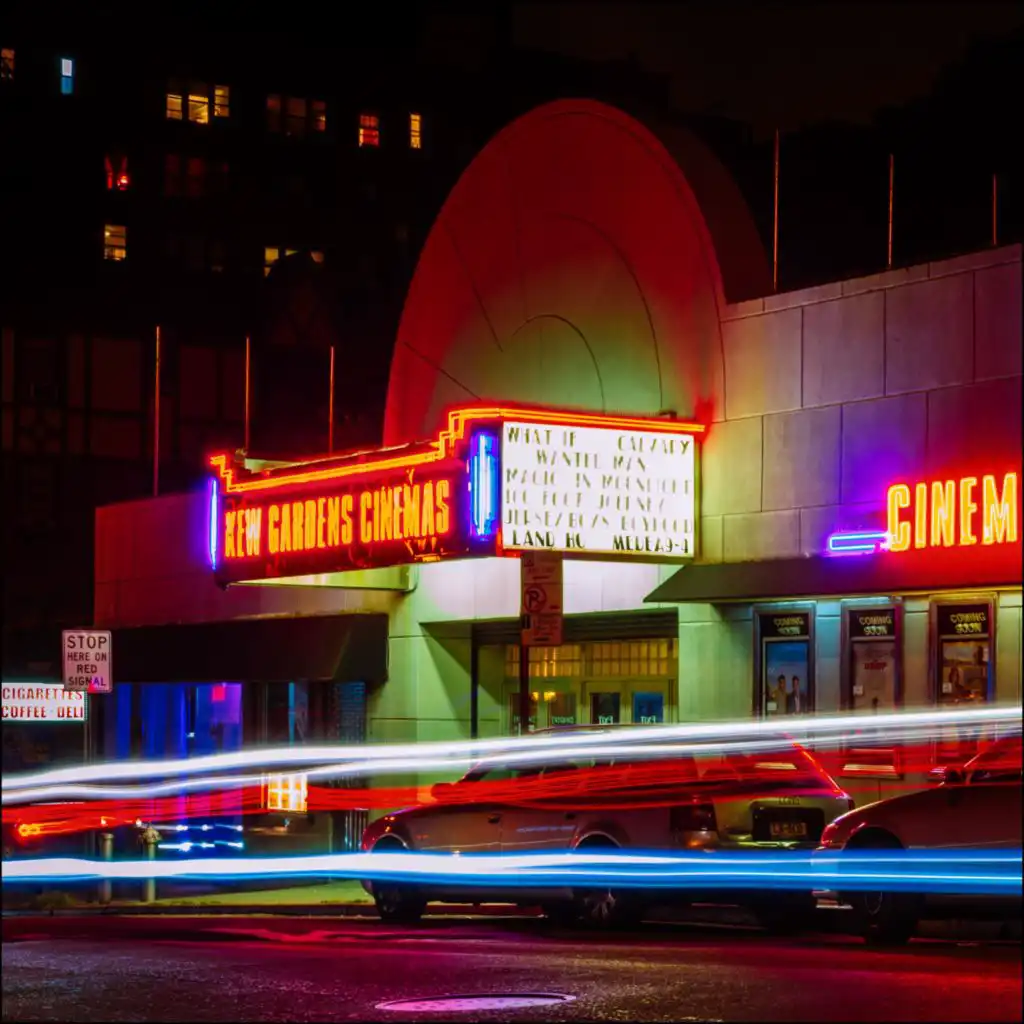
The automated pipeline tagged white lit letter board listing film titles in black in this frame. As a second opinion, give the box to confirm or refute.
[502,419,696,560]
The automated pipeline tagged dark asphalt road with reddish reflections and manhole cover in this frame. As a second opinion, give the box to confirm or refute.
[3,918,1021,1022]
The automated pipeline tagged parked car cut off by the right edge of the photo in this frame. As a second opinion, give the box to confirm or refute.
[819,733,1021,944]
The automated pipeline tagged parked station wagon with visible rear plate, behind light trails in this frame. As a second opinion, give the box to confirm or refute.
[362,730,853,931]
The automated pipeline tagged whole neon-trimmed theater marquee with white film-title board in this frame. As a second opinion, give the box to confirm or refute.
[209,408,705,584]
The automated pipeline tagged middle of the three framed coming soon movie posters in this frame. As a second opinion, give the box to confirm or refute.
[841,604,903,778]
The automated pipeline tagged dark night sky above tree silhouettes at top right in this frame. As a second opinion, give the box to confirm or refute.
[514,0,1024,135]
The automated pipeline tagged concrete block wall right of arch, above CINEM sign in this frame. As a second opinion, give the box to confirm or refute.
[701,246,1022,561]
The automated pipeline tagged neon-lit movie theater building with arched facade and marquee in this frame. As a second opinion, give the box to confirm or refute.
[90,101,1022,807]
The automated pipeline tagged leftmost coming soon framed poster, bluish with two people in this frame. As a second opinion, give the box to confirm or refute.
[754,608,814,718]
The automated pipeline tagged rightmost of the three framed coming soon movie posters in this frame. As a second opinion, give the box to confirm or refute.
[931,599,995,765]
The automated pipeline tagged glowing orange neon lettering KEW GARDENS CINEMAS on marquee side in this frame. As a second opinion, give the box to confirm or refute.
[224,478,452,560]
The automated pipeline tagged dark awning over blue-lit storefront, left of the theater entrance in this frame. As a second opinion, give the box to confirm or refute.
[112,614,388,685]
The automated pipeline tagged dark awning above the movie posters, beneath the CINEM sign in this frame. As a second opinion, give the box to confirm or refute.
[644,544,1021,604]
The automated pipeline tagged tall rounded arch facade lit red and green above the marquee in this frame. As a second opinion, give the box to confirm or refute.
[384,100,767,444]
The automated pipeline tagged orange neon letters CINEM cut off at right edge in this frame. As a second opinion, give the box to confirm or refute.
[886,473,1020,552]
